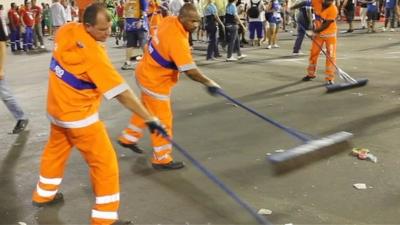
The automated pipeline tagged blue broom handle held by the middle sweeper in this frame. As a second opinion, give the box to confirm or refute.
[217,89,312,142]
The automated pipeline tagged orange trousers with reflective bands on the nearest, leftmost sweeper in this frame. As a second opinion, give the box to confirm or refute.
[32,121,119,225]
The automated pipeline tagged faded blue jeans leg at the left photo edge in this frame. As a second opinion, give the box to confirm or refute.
[0,78,26,120]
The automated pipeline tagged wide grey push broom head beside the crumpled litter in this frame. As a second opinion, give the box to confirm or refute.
[268,131,353,164]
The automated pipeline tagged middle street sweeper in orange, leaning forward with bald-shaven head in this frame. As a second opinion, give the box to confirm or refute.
[118,3,220,170]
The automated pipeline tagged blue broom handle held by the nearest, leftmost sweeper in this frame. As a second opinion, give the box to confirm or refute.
[163,134,272,225]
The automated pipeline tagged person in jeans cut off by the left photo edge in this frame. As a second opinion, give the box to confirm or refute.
[0,15,28,134]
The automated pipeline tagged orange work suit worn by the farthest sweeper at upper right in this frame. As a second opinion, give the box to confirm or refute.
[307,0,338,81]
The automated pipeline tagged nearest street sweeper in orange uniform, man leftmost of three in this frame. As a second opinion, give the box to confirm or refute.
[32,3,166,225]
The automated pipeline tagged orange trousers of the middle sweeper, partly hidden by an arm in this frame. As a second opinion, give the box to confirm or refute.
[119,92,172,164]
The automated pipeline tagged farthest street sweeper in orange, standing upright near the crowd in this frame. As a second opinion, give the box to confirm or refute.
[303,0,338,85]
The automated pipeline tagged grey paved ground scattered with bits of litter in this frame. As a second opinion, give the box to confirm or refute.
[0,21,400,224]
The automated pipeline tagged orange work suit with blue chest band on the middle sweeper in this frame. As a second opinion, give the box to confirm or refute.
[119,16,196,164]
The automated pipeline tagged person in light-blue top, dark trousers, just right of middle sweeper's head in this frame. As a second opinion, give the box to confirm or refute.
[204,0,225,60]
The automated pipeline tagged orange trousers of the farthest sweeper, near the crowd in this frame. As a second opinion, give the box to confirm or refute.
[307,35,337,81]
